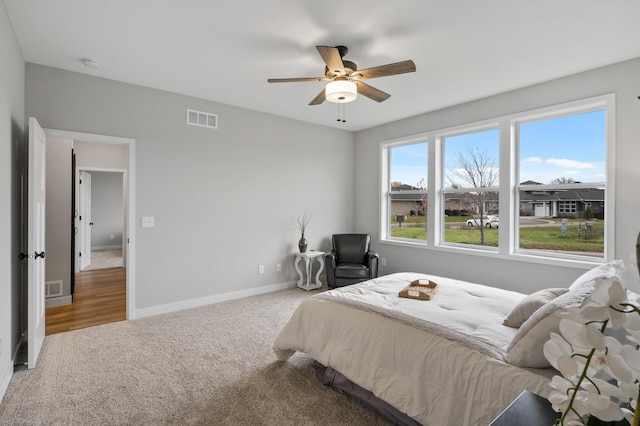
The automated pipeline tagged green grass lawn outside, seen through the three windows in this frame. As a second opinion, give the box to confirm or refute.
[391,216,604,253]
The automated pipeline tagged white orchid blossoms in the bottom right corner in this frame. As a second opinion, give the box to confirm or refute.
[544,278,640,426]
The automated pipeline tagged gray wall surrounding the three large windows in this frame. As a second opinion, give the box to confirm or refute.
[355,59,640,293]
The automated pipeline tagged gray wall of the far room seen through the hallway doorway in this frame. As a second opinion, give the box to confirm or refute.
[89,171,124,250]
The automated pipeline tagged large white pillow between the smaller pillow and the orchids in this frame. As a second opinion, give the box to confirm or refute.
[504,260,624,368]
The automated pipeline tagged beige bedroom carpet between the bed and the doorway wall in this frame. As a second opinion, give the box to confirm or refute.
[0,288,386,425]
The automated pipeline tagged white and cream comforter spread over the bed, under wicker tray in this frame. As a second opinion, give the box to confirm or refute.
[274,273,555,426]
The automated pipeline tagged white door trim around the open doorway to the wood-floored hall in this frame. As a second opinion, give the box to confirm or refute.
[43,128,136,320]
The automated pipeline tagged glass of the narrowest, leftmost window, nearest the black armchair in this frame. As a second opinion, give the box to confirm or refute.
[388,142,428,241]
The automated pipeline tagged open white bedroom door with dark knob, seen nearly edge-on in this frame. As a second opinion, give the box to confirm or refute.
[27,117,46,368]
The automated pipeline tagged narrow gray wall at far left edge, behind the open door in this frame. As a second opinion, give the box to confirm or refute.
[0,2,25,397]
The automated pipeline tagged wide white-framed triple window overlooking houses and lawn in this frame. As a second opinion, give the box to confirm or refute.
[380,95,615,262]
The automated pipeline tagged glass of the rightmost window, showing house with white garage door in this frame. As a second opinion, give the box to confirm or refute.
[518,110,606,257]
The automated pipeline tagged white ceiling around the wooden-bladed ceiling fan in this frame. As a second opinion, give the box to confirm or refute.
[4,0,640,131]
